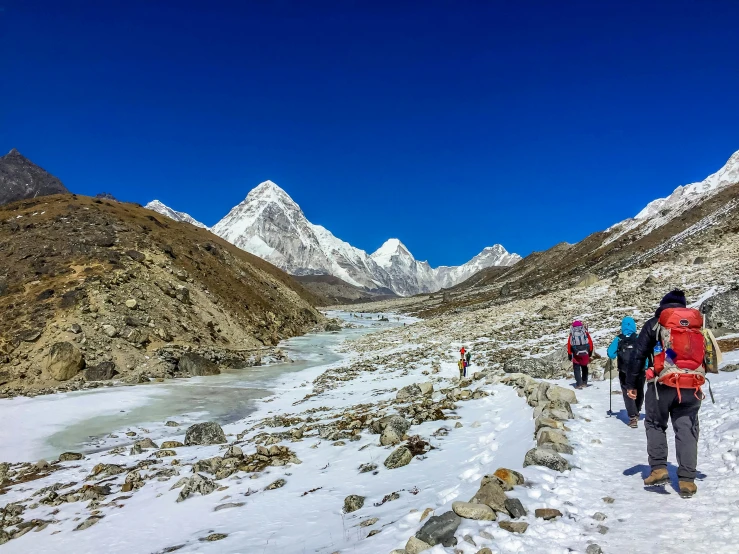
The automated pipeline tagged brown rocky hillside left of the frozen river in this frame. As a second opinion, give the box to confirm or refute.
[0,195,322,395]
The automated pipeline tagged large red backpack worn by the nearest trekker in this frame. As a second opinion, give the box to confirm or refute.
[654,308,706,398]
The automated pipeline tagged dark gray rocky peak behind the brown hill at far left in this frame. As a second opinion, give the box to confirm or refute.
[0,148,69,205]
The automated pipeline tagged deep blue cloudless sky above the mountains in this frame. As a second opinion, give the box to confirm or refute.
[0,0,739,265]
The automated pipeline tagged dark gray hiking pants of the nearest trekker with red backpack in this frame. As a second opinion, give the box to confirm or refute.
[644,383,701,482]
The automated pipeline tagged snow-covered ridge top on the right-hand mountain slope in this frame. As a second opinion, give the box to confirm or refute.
[603,150,739,245]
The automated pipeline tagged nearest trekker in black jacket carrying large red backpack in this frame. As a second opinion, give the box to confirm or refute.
[626,290,706,498]
